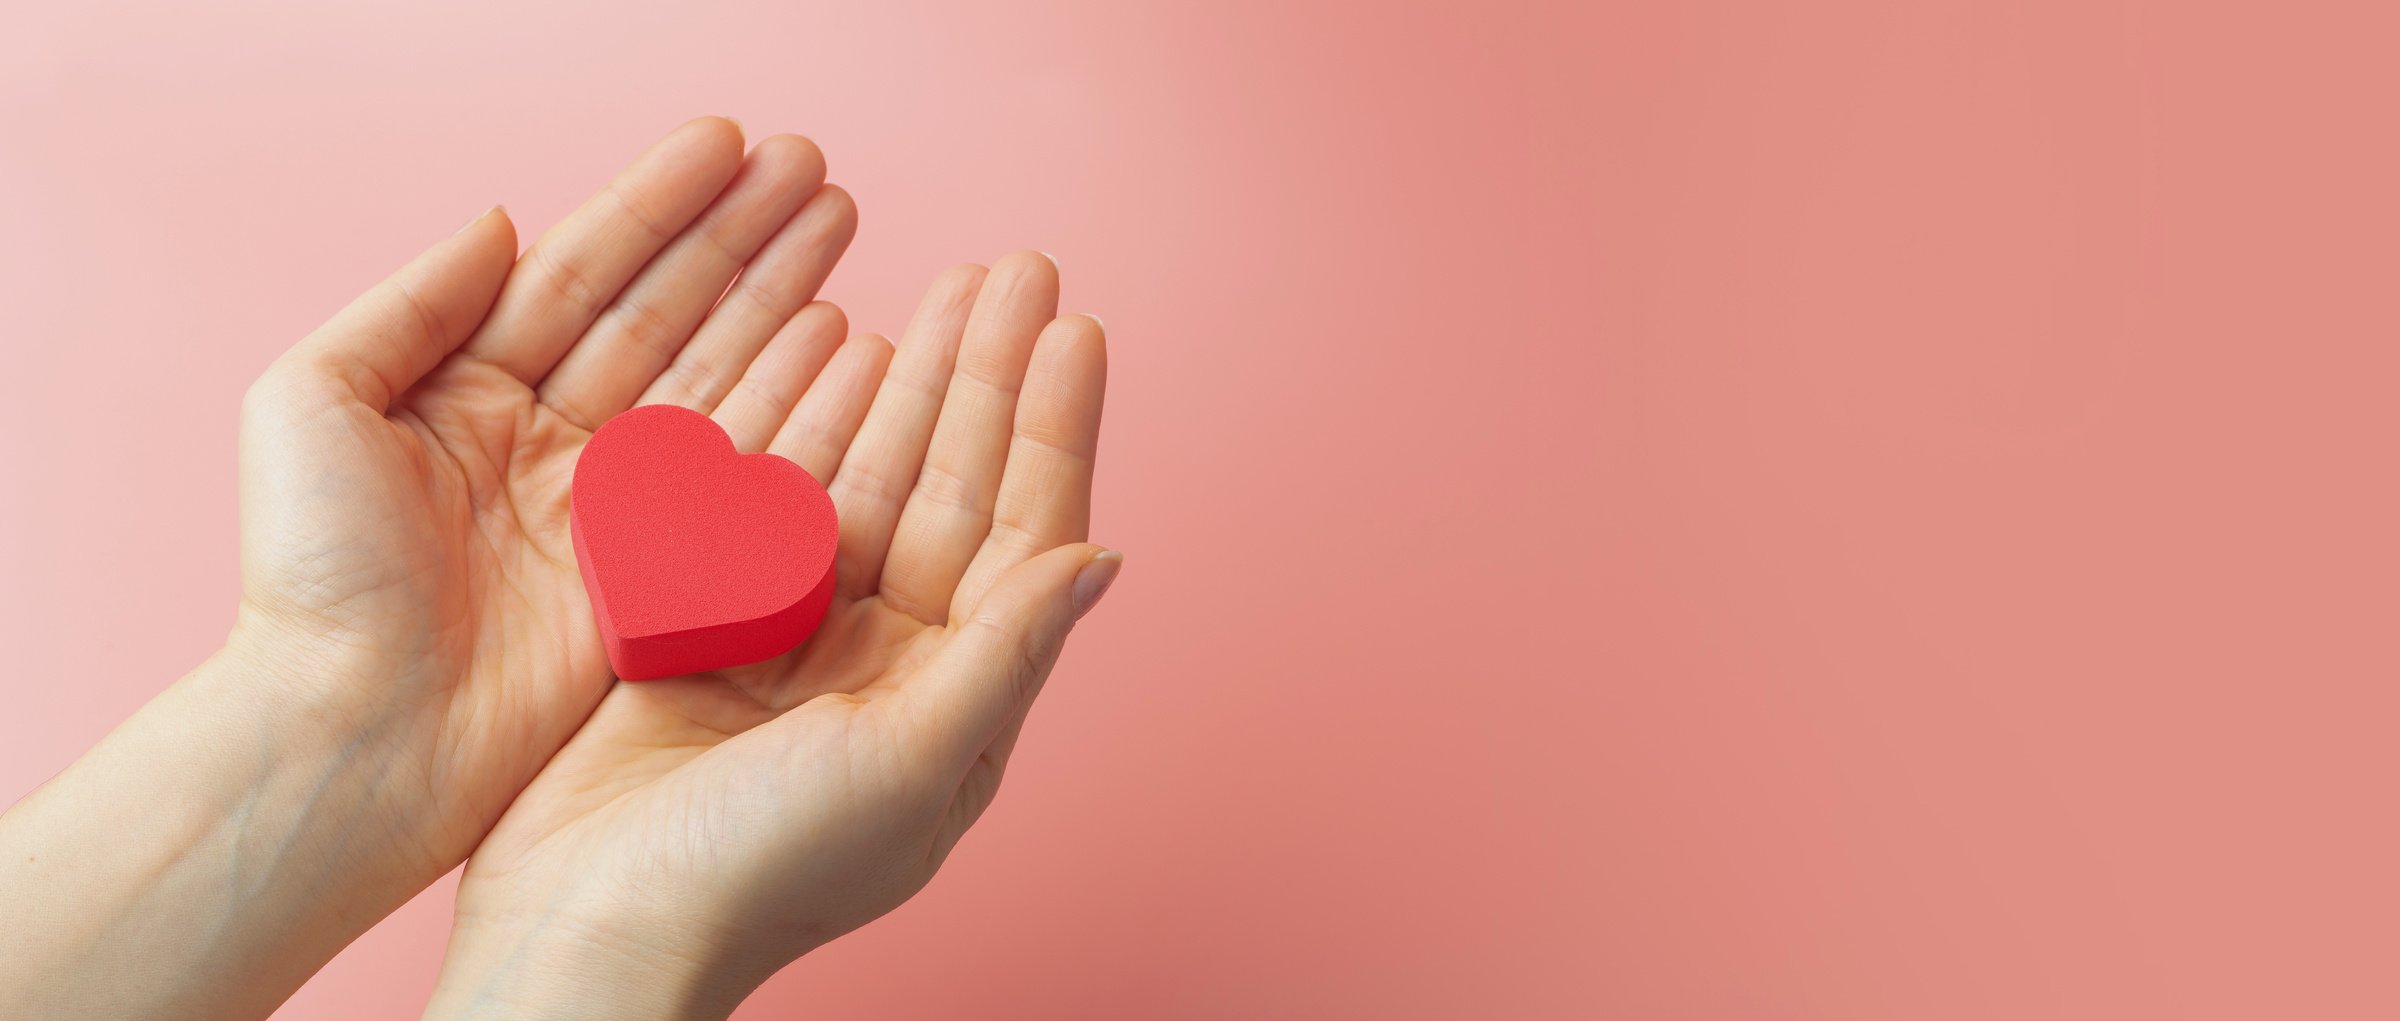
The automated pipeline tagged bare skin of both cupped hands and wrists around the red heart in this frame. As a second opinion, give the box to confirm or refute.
[0,118,1121,1019]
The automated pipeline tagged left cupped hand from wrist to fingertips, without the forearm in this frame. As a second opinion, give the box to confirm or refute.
[233,118,864,869]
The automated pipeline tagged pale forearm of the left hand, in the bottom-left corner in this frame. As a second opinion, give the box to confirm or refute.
[0,646,442,1019]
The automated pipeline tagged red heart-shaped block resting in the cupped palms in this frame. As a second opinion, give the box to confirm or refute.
[569,404,840,680]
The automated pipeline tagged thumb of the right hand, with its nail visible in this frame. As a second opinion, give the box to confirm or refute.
[883,543,1126,783]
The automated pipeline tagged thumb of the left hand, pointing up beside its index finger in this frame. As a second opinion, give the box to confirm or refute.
[283,207,516,411]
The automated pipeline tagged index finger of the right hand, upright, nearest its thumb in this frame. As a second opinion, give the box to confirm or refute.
[950,315,1109,615]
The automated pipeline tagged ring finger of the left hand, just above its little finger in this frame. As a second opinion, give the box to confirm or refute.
[636,185,859,411]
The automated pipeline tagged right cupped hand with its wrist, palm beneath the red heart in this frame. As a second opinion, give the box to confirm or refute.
[432,252,1121,1016]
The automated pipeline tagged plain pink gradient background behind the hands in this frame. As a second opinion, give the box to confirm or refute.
[0,0,2400,1019]
